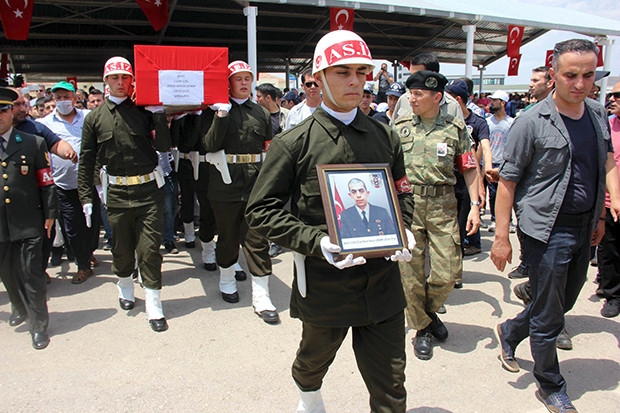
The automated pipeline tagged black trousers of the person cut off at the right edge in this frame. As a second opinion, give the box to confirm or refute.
[597,208,620,300]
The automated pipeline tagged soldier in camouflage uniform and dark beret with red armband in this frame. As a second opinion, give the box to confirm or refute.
[395,70,480,360]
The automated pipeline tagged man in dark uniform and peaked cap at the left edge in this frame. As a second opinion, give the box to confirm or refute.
[0,88,58,350]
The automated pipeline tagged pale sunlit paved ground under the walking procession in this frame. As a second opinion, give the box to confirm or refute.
[0,222,620,413]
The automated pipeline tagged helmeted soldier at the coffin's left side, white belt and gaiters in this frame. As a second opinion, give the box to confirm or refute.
[78,57,171,332]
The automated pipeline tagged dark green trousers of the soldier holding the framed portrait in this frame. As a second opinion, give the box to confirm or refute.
[292,311,407,413]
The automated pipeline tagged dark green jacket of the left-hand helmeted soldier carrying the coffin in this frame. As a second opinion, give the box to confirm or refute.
[78,98,172,208]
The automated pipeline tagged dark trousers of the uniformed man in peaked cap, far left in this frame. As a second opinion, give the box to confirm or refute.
[0,237,49,333]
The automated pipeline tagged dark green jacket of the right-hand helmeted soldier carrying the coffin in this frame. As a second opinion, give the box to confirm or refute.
[201,99,272,202]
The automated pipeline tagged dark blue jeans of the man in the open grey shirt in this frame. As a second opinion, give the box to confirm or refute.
[502,225,591,394]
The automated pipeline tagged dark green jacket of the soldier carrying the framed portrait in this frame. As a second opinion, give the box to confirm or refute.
[246,107,413,327]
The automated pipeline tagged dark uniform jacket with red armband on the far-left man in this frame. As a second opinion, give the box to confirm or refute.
[0,129,58,242]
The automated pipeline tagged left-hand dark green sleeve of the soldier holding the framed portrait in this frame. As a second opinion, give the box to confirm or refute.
[246,138,327,257]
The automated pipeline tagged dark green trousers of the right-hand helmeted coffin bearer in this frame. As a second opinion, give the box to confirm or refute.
[211,200,271,277]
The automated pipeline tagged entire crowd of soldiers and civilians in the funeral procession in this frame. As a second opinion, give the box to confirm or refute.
[0,30,620,413]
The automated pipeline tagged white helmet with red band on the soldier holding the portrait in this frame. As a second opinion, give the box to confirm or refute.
[312,30,375,75]
